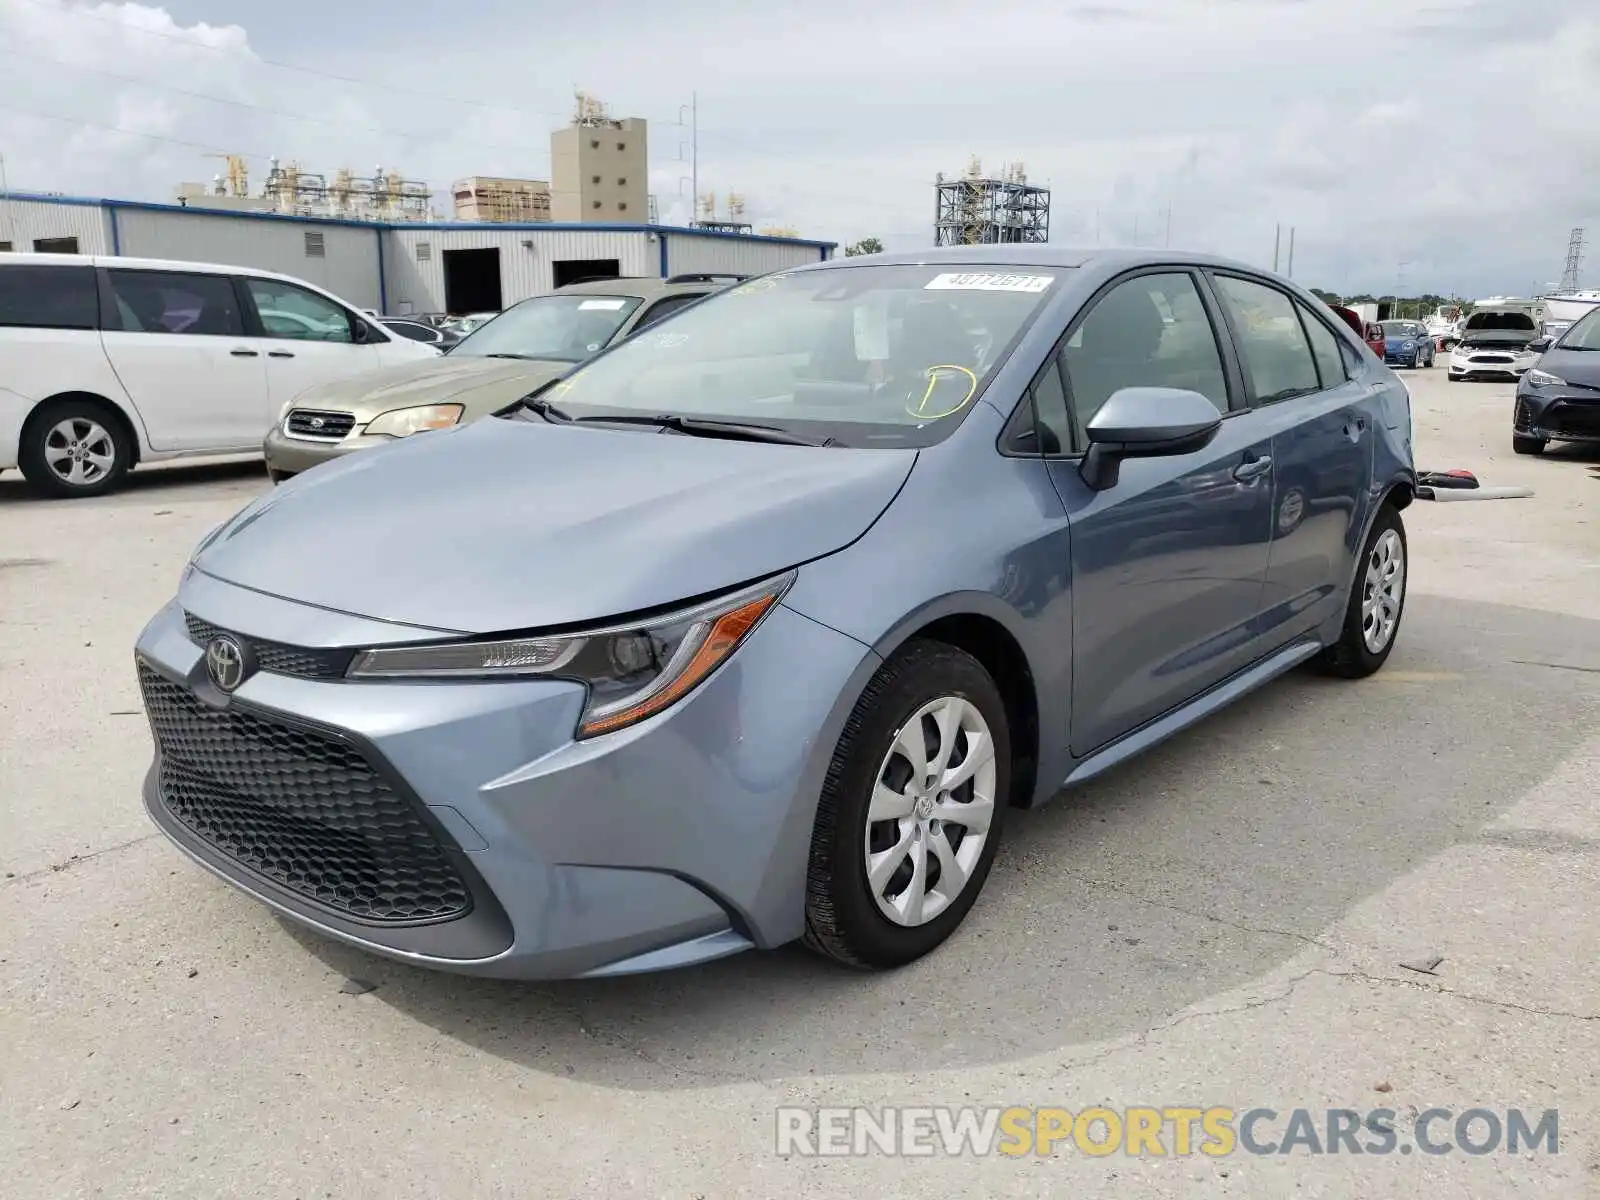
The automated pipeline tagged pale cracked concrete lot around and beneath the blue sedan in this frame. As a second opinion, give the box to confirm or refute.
[0,368,1600,1200]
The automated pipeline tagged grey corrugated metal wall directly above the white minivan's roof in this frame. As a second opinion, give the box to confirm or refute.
[115,208,381,309]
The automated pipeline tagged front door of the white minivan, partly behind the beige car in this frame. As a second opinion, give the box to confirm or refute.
[240,275,382,416]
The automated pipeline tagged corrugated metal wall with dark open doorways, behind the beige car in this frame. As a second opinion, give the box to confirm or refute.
[384,229,661,312]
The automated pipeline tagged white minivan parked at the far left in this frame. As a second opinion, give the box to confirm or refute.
[0,253,438,496]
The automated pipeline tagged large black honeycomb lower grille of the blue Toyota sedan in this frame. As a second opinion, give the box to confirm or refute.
[139,662,472,925]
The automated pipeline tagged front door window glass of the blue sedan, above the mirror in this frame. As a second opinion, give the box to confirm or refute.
[1062,272,1227,445]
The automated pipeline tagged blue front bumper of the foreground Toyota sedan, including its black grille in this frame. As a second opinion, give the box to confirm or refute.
[136,573,877,979]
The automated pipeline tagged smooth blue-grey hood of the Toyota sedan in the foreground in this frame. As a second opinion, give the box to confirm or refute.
[195,419,917,634]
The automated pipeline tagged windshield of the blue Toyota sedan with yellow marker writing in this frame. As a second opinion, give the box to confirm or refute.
[531,264,1064,446]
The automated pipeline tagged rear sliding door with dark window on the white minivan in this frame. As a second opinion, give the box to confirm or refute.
[101,267,267,451]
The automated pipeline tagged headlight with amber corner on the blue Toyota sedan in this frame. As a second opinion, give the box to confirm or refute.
[347,571,795,738]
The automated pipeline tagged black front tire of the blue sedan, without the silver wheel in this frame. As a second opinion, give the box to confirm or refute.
[803,638,1011,970]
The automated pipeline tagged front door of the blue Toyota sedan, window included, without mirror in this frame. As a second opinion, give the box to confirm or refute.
[1035,267,1272,757]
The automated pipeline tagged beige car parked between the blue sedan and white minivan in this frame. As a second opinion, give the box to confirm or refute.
[262,275,726,482]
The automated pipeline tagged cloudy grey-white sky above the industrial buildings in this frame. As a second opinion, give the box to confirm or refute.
[0,0,1600,296]
